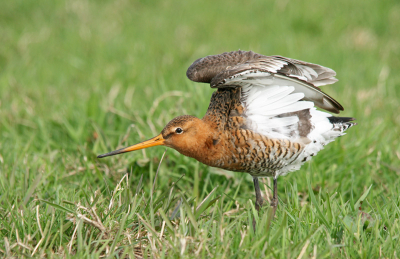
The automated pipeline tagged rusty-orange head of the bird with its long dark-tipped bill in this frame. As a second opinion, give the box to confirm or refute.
[98,115,207,158]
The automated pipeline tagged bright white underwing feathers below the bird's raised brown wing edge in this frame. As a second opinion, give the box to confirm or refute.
[225,71,314,140]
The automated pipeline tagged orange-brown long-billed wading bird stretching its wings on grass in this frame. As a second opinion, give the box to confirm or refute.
[98,50,357,225]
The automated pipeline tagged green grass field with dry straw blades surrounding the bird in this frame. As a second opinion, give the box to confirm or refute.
[0,0,400,258]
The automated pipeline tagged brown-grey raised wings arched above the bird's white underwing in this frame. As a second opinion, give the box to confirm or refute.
[186,50,343,113]
